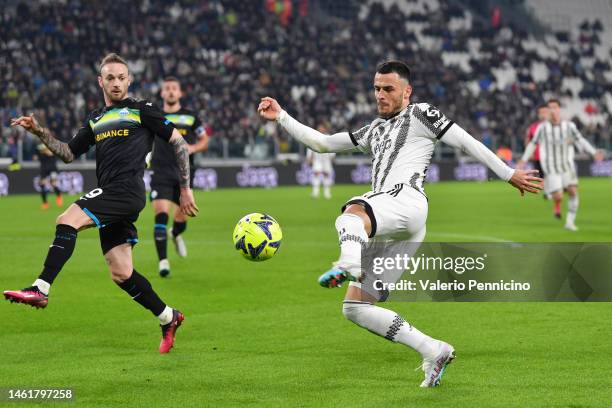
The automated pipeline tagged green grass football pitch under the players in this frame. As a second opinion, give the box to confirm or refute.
[0,179,612,407]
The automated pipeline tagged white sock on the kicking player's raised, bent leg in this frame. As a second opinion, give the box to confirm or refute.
[336,214,369,278]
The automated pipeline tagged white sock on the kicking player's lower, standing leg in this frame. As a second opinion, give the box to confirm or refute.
[342,300,439,357]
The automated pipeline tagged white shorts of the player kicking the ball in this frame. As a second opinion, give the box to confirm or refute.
[342,184,429,288]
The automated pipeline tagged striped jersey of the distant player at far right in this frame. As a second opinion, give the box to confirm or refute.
[523,120,595,174]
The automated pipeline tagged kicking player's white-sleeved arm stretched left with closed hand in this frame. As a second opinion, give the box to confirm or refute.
[257,97,356,153]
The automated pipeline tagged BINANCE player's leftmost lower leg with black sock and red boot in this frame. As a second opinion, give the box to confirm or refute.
[4,204,94,308]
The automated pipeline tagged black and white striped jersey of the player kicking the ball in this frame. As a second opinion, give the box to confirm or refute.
[349,103,453,192]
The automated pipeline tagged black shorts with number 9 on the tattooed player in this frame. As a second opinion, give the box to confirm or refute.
[75,182,146,254]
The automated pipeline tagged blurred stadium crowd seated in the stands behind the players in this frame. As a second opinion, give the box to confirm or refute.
[0,0,612,160]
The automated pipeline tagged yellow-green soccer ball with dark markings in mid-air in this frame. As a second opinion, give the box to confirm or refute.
[233,213,283,261]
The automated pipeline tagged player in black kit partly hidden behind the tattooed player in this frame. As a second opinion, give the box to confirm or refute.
[151,77,208,277]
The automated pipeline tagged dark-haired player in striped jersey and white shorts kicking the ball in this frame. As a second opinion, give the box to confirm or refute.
[258,61,541,387]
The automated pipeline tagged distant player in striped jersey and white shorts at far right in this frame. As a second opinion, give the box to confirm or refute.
[517,99,603,231]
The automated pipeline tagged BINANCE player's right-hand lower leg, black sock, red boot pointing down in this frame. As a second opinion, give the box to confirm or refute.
[104,244,185,353]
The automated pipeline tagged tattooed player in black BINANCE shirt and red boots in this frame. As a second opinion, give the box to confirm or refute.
[4,54,198,353]
